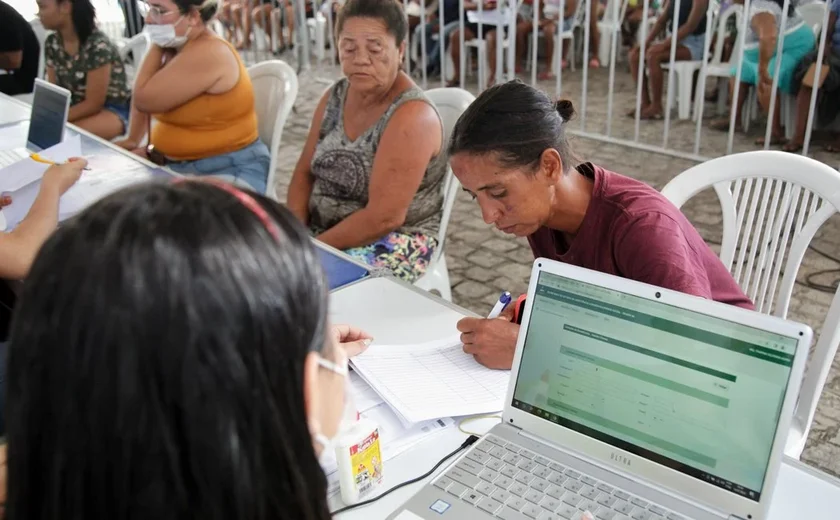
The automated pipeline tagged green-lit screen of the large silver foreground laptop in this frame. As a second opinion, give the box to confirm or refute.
[512,272,797,501]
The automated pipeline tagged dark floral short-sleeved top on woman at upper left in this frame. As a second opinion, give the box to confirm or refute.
[44,29,131,105]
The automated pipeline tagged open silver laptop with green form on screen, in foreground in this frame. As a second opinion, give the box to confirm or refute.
[390,258,812,520]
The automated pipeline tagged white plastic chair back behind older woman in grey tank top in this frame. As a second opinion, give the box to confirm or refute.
[426,88,475,261]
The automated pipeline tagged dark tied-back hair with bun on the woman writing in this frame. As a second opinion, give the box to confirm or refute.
[448,80,576,172]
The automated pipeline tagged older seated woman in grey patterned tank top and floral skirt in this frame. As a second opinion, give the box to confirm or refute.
[288,0,446,282]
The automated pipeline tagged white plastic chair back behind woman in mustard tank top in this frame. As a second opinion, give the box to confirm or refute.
[248,60,298,198]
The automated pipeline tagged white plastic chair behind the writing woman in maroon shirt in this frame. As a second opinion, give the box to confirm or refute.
[662,151,840,458]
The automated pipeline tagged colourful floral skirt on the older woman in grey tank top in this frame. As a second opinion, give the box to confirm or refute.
[345,232,437,283]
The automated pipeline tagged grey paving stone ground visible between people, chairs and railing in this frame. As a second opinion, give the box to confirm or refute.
[266,59,840,476]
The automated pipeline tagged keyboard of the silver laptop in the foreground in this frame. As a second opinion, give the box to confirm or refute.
[434,435,686,520]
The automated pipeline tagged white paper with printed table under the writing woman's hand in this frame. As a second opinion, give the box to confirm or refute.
[351,336,510,423]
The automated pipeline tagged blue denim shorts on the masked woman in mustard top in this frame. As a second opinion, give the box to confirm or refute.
[167,139,271,193]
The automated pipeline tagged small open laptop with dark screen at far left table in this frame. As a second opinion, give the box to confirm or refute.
[0,79,70,168]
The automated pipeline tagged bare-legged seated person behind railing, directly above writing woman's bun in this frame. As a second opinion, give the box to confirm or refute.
[516,0,578,80]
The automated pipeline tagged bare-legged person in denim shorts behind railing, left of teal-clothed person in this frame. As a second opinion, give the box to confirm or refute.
[627,0,709,119]
